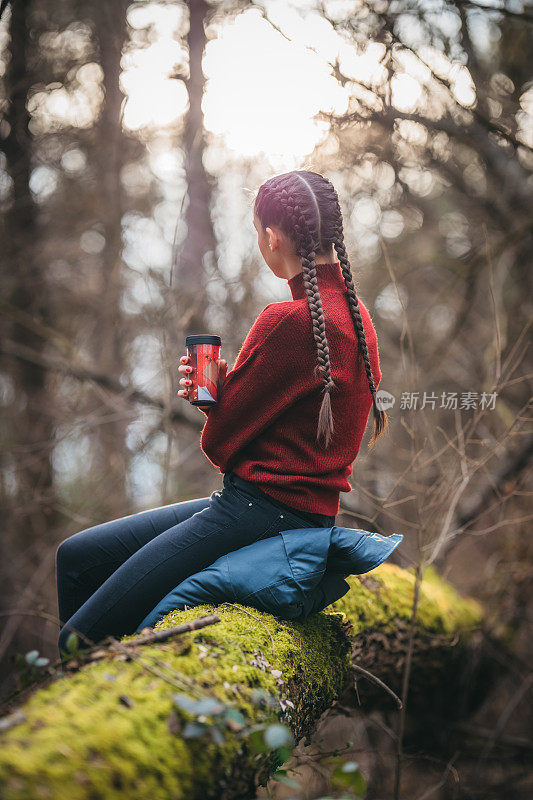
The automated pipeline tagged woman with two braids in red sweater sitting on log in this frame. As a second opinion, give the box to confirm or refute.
[56,170,387,654]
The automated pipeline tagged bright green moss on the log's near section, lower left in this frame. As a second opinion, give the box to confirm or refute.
[0,606,349,800]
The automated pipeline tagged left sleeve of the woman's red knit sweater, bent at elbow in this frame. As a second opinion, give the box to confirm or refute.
[200,303,310,473]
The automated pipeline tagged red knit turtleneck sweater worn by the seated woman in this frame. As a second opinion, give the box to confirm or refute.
[200,261,381,515]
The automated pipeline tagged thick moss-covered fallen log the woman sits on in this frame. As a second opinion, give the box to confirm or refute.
[0,563,482,800]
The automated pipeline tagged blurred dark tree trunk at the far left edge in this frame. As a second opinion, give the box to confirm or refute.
[0,0,57,604]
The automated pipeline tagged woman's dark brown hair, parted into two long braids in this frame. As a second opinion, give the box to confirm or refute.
[254,170,388,448]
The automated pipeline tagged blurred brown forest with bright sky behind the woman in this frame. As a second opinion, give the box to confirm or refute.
[0,0,533,800]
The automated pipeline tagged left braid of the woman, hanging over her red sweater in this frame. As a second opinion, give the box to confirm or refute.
[278,187,337,448]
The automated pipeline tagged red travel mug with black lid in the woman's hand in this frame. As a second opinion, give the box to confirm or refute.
[185,333,221,406]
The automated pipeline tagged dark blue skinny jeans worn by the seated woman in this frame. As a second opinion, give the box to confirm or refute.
[56,472,335,656]
